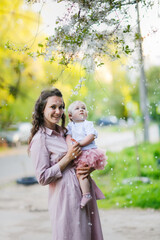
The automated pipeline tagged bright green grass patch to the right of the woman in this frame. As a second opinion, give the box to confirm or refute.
[93,143,160,209]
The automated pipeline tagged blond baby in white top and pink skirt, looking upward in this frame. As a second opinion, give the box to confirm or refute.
[66,101,107,208]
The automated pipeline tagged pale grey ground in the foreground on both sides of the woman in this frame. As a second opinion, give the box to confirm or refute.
[0,182,160,240]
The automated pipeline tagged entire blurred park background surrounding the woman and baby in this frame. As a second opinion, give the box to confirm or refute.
[0,0,160,240]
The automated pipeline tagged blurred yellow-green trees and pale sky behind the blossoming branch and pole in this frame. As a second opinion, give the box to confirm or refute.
[0,0,160,134]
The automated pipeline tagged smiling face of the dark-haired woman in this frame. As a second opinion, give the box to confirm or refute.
[43,96,64,129]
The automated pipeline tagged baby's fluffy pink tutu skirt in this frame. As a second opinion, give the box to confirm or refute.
[75,148,107,169]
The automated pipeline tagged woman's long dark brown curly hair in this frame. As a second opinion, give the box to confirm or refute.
[28,88,66,144]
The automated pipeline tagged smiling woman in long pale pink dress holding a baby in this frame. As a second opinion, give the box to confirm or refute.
[29,88,104,240]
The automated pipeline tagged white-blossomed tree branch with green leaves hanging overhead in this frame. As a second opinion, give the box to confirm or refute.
[25,0,154,71]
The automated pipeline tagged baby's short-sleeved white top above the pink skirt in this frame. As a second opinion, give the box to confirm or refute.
[67,120,98,150]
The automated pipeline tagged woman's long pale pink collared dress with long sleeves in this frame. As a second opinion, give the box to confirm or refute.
[30,127,104,240]
